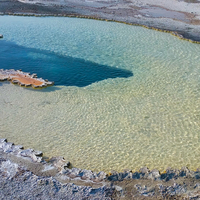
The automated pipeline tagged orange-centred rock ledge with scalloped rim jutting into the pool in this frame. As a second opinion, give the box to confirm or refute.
[0,69,54,89]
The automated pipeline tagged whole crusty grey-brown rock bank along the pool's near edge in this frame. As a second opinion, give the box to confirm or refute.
[0,139,200,199]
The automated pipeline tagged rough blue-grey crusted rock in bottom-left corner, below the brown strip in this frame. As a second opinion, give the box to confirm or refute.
[0,161,114,200]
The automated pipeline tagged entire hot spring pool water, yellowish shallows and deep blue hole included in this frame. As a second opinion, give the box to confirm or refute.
[0,16,200,172]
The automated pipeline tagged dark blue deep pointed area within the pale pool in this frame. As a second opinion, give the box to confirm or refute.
[0,40,133,87]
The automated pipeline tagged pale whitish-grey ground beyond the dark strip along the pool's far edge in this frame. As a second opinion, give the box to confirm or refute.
[16,0,200,41]
